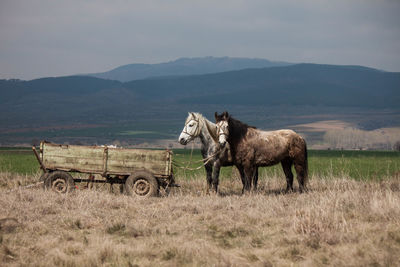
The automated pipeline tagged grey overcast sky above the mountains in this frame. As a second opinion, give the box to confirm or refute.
[0,0,400,79]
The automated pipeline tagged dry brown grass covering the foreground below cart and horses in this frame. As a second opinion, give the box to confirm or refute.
[0,174,400,266]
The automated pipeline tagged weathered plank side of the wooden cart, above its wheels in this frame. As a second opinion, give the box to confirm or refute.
[38,142,172,176]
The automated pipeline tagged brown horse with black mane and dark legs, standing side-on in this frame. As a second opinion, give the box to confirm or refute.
[215,111,308,192]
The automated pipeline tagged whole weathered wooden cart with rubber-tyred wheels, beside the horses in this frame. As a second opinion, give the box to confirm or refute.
[32,141,178,197]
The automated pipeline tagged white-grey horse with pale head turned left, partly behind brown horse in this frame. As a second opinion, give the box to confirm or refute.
[179,112,234,192]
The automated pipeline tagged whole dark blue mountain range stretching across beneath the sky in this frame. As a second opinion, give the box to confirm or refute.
[0,58,400,144]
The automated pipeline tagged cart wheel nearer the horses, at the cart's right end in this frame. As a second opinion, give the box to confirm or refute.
[125,172,158,197]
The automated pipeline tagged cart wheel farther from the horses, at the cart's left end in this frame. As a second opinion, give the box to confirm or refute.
[44,171,75,193]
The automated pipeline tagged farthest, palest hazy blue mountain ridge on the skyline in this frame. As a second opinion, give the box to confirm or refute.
[88,57,291,82]
